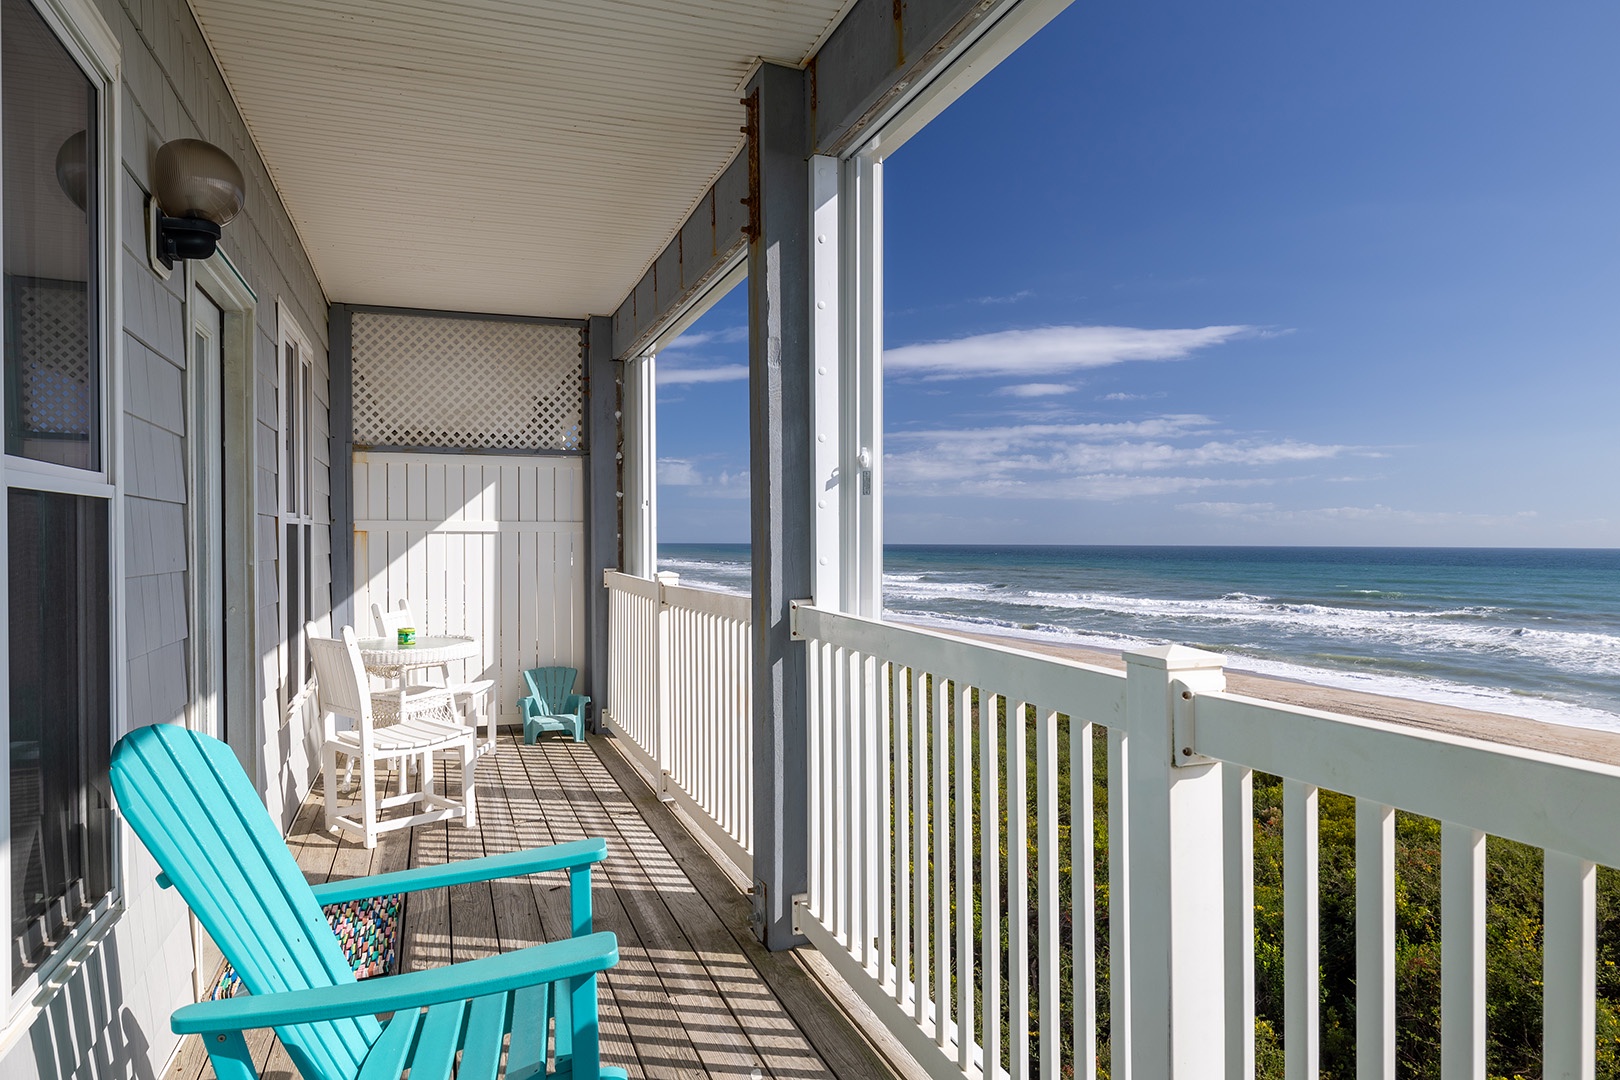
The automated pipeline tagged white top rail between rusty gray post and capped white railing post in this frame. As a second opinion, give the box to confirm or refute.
[794,601,1124,725]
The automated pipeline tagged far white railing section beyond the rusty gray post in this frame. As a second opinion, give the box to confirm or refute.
[603,570,753,878]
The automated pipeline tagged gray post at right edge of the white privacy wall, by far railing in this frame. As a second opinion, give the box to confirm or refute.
[585,316,620,732]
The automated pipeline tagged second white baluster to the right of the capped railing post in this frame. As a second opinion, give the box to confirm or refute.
[1283,779,1320,1080]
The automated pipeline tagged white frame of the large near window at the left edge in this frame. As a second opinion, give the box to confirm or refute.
[0,0,130,1023]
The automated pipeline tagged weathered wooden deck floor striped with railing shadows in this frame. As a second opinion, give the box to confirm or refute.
[165,737,893,1080]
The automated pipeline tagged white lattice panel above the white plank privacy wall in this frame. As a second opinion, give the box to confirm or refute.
[352,311,585,450]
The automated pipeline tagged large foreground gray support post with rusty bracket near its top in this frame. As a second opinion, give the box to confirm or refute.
[745,63,815,949]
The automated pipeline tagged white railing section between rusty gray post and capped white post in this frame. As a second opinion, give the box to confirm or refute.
[795,606,1126,1077]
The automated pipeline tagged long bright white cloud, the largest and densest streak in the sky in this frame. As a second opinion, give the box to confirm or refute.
[883,325,1259,379]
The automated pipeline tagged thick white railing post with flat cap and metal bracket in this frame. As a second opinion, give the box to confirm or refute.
[1124,646,1226,1080]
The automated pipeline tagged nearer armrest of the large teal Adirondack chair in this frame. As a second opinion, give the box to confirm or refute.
[168,931,619,1035]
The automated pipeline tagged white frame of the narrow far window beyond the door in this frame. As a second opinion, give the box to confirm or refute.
[275,300,316,712]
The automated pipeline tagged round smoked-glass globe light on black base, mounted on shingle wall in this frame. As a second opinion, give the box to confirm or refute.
[146,139,243,277]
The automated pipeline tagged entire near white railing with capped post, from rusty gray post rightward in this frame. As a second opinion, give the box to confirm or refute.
[794,604,1620,1080]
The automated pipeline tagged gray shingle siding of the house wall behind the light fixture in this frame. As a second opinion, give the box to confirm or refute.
[0,0,332,1080]
